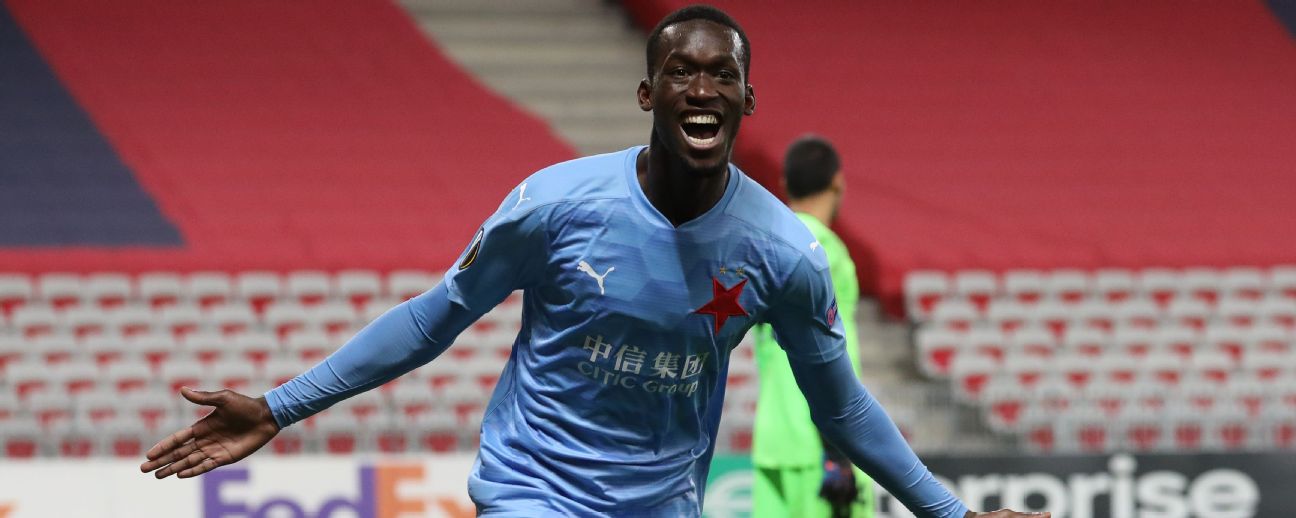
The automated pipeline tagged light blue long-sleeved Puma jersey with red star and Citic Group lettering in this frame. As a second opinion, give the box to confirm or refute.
[267,148,964,517]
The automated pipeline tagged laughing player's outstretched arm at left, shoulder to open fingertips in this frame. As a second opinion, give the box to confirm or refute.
[140,180,547,478]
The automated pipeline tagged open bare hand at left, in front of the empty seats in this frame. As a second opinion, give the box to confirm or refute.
[140,387,279,479]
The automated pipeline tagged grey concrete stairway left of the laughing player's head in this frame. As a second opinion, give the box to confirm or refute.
[402,0,649,154]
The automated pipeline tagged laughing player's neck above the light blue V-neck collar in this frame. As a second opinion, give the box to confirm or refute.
[635,136,730,227]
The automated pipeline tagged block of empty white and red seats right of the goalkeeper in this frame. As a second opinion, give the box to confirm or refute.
[906,265,1296,452]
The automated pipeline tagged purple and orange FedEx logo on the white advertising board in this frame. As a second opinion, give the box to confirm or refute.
[201,464,476,518]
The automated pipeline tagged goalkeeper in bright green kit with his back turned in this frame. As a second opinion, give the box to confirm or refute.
[752,136,874,518]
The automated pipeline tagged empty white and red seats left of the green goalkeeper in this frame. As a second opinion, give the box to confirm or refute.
[0,269,756,457]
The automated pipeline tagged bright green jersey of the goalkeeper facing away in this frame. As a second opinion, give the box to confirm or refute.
[752,212,859,467]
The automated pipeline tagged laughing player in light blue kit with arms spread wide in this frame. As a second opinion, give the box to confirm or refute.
[140,6,1047,518]
